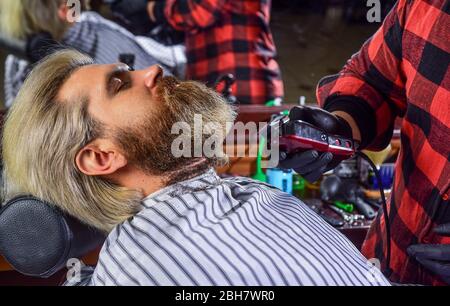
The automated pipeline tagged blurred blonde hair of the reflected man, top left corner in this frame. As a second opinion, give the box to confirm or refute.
[0,0,67,40]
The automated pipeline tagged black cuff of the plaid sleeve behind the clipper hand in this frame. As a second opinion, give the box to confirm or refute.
[323,95,377,150]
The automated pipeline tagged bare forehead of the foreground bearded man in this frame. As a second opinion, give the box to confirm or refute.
[58,65,115,101]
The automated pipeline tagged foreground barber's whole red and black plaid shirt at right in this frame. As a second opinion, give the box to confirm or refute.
[318,0,450,284]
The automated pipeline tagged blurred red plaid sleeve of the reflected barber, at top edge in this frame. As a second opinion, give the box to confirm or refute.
[155,0,226,31]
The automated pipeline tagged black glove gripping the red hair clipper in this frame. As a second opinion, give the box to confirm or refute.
[279,106,353,182]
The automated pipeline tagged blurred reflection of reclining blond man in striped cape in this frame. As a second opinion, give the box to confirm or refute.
[0,0,179,107]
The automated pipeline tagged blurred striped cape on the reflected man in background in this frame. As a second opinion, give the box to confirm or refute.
[4,12,186,107]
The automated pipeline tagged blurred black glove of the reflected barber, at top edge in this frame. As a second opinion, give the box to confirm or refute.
[107,0,155,35]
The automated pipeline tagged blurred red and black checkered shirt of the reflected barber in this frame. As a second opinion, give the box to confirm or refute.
[155,0,284,104]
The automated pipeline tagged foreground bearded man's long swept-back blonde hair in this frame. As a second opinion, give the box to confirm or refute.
[2,50,143,231]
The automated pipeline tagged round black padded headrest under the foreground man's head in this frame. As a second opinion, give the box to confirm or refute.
[0,196,105,278]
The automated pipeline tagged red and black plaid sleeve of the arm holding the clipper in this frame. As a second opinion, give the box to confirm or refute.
[317,0,413,150]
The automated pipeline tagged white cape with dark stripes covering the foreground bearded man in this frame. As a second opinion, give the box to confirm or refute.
[68,171,389,286]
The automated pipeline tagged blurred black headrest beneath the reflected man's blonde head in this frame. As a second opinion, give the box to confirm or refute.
[26,32,60,64]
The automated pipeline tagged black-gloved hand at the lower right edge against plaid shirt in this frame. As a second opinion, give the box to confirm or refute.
[407,223,450,285]
